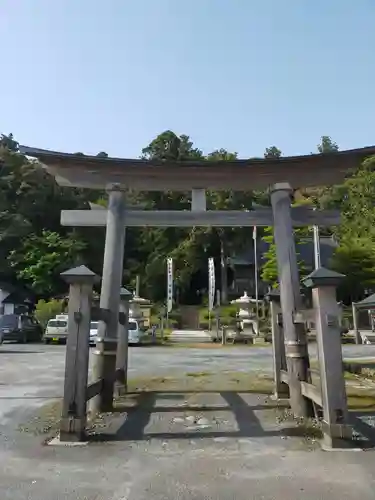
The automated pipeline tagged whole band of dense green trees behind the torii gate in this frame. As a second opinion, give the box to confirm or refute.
[0,131,375,304]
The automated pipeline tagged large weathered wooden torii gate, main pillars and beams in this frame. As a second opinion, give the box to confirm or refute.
[20,147,375,417]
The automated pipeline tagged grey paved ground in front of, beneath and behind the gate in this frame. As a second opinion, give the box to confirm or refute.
[0,344,375,500]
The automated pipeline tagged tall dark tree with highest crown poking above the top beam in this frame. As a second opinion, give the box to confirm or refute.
[129,130,203,301]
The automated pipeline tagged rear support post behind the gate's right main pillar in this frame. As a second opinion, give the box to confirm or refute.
[266,289,289,399]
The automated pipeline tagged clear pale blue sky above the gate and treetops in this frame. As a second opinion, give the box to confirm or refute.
[0,0,375,158]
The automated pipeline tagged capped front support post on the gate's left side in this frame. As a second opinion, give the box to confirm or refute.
[60,266,99,441]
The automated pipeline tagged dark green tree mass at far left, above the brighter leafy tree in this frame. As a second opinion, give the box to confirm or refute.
[0,134,104,293]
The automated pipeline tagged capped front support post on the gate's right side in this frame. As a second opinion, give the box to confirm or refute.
[303,267,352,448]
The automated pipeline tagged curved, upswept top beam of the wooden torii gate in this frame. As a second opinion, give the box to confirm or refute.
[20,146,375,191]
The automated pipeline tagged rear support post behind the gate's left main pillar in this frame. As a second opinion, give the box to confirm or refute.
[116,288,133,396]
